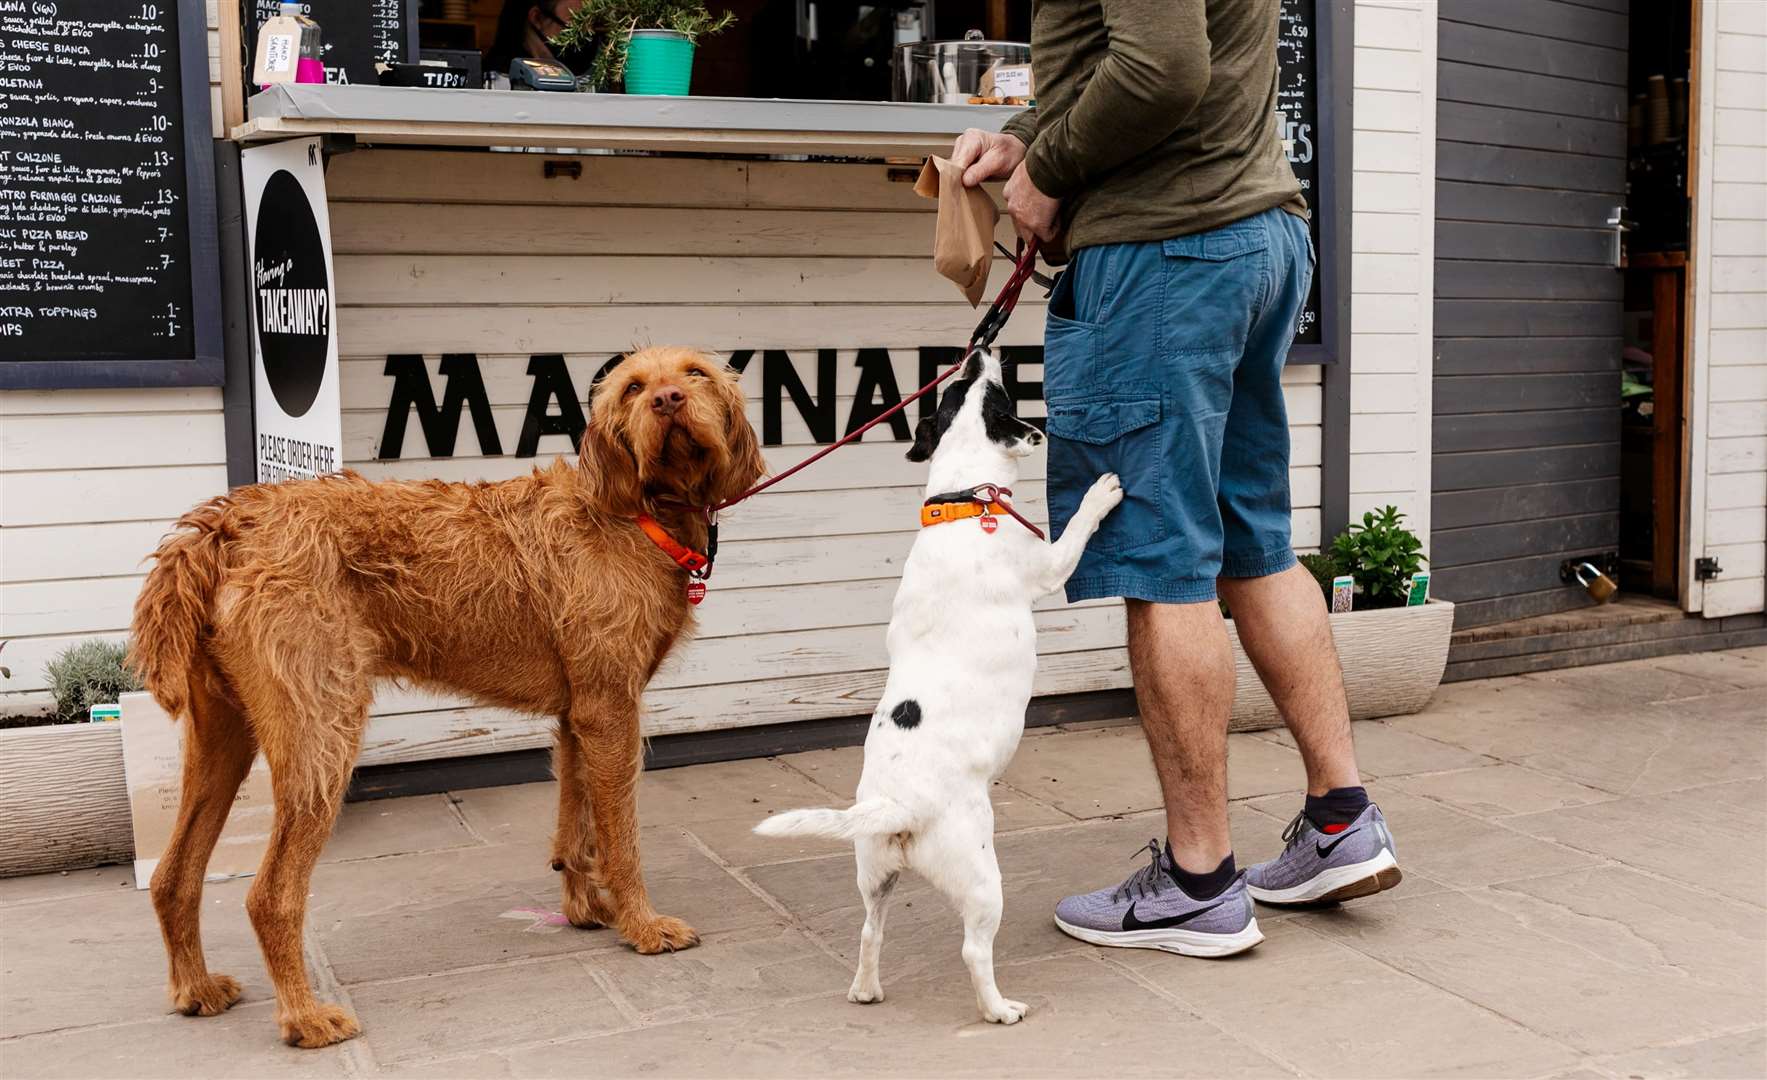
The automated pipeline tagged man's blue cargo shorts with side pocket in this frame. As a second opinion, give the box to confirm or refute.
[1043,209,1313,605]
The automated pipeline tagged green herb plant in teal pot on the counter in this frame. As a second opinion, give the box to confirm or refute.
[553,0,737,97]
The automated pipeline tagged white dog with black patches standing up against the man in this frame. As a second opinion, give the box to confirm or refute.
[755,352,1122,1023]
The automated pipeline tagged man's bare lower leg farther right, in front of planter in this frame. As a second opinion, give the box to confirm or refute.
[1222,566,1362,798]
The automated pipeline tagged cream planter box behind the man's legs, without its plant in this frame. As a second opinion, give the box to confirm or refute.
[1226,599,1454,732]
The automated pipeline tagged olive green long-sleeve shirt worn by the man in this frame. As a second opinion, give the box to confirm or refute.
[1005,0,1308,251]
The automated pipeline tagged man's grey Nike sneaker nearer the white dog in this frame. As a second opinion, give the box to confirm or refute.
[1055,840,1263,956]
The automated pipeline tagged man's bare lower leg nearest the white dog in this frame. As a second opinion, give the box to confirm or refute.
[1127,599,1233,873]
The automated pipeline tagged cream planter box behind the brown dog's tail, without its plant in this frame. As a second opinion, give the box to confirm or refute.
[0,723,134,877]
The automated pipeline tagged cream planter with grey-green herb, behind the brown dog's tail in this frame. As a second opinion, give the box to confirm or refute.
[0,640,141,877]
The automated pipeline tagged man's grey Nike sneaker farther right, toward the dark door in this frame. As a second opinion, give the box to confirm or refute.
[1246,802,1403,903]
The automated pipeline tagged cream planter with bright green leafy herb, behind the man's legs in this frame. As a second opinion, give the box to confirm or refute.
[1228,506,1454,730]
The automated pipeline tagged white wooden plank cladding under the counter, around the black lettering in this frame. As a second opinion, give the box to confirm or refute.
[327,150,1320,749]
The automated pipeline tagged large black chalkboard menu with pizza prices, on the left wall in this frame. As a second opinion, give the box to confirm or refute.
[0,0,221,389]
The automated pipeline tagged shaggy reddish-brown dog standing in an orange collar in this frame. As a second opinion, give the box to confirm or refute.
[131,348,763,1046]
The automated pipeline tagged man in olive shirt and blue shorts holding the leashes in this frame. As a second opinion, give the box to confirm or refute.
[951,0,1399,956]
